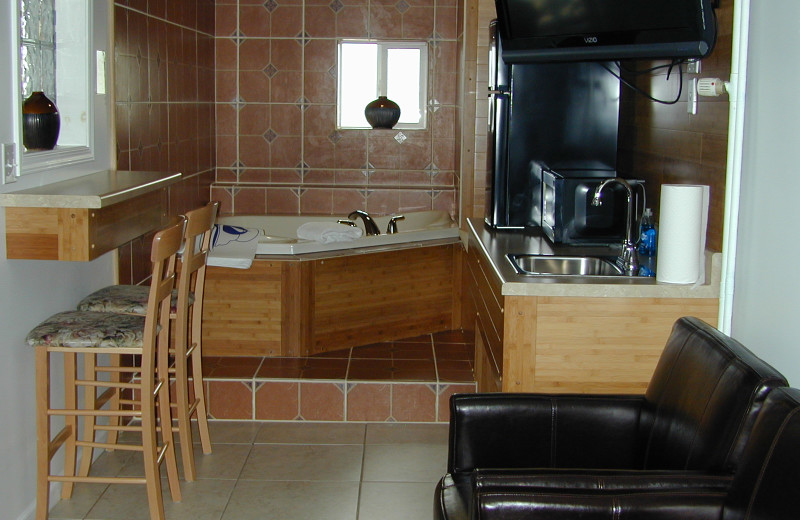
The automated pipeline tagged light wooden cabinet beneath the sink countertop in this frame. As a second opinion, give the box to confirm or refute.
[466,234,718,393]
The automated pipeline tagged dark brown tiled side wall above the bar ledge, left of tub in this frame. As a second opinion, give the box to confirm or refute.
[114,0,215,283]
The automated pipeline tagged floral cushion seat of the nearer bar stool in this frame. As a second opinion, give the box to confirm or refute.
[26,311,145,348]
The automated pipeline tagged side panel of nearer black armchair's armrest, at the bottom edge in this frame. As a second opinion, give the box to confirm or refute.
[473,491,725,520]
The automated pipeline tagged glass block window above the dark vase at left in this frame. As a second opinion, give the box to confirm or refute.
[19,0,56,101]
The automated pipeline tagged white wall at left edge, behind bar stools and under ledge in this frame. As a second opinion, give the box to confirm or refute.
[0,1,113,520]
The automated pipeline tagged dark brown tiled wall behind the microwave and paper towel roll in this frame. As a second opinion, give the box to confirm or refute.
[618,2,733,251]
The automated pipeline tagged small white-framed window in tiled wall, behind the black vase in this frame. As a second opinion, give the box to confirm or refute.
[337,40,428,129]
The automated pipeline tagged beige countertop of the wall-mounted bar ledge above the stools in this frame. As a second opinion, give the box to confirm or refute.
[0,170,181,208]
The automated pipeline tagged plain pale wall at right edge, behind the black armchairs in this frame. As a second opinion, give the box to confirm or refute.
[731,0,800,386]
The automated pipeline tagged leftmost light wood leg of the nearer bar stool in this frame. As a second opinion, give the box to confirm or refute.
[36,347,50,520]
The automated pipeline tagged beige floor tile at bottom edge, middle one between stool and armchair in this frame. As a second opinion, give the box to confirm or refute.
[217,480,358,520]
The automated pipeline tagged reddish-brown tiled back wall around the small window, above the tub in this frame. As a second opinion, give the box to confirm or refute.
[212,0,461,219]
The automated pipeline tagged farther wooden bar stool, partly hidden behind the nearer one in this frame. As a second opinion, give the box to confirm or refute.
[78,202,219,481]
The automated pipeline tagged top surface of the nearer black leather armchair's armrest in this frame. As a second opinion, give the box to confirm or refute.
[472,468,733,494]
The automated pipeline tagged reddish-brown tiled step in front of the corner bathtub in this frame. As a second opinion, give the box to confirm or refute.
[203,331,475,422]
